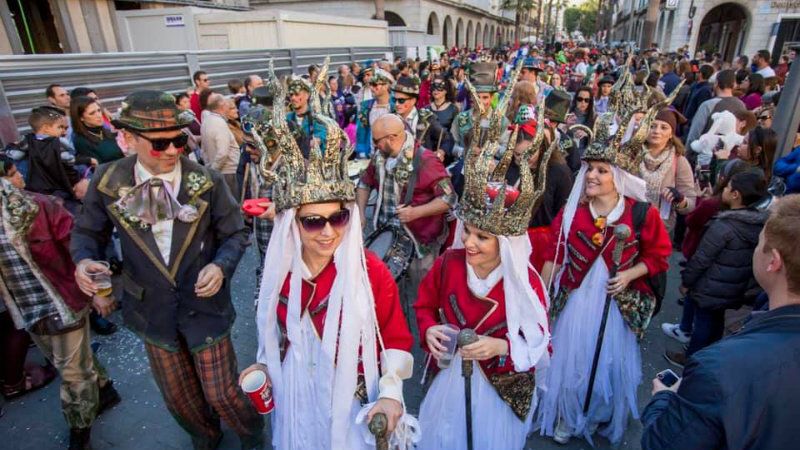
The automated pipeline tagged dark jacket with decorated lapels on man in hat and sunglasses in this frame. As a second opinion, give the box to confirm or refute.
[70,155,248,351]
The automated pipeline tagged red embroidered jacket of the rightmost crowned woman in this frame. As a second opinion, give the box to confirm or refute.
[545,197,672,293]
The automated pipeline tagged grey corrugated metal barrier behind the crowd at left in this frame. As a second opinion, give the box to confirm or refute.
[0,47,395,145]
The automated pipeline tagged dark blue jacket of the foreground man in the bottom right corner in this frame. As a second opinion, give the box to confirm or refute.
[642,305,800,450]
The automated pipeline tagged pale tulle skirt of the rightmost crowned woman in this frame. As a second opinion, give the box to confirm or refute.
[536,258,642,443]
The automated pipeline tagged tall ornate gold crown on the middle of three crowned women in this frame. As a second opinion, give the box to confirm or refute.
[456,65,557,236]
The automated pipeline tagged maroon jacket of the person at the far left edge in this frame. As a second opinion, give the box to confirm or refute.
[26,192,91,313]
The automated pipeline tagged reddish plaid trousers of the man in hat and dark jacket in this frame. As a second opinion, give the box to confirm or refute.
[145,336,264,450]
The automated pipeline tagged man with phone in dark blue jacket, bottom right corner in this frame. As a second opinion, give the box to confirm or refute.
[641,195,800,450]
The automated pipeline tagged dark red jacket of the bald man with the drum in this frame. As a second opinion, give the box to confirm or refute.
[361,146,453,244]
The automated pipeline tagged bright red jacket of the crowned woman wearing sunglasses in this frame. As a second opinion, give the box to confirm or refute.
[277,250,414,360]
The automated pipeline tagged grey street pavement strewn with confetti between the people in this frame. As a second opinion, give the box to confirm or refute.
[0,247,680,450]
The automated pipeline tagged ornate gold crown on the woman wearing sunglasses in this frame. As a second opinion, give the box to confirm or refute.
[261,68,355,211]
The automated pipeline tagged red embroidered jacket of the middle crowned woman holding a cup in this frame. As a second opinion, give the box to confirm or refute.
[414,249,547,377]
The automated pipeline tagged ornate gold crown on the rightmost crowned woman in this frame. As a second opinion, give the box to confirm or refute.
[581,81,684,174]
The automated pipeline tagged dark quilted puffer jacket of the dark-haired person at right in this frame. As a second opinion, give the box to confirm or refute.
[681,209,767,309]
